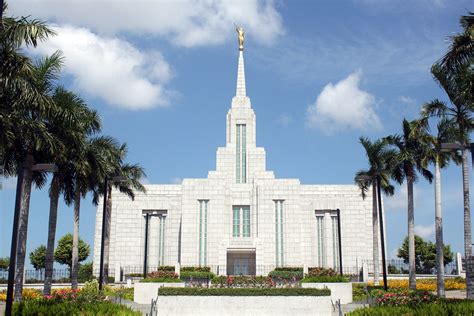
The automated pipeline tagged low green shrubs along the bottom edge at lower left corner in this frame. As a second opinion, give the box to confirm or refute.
[13,299,141,316]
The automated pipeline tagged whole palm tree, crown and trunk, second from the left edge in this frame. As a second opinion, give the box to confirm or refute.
[43,87,100,295]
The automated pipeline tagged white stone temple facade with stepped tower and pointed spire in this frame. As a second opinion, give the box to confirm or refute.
[94,48,378,275]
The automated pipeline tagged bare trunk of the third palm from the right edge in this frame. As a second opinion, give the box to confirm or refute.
[407,176,416,290]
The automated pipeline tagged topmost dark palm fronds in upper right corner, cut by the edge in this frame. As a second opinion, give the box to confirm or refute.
[437,12,474,74]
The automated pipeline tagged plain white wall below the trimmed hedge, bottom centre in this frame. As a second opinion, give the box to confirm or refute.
[158,296,332,316]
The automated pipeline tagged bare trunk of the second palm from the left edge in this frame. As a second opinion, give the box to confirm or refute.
[43,175,59,295]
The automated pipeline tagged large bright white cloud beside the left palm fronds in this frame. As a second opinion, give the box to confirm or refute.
[34,26,172,110]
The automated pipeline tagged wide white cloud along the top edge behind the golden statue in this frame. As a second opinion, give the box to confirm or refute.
[10,0,284,47]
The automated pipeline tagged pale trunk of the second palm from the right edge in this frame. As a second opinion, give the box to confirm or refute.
[435,157,446,297]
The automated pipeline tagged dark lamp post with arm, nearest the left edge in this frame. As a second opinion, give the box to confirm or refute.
[5,156,58,316]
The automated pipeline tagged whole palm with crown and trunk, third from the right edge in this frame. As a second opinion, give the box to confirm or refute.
[386,119,433,290]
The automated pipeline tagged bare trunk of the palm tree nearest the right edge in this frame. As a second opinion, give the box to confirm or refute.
[462,149,474,299]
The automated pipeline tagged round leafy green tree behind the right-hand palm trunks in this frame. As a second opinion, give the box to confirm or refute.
[397,235,454,274]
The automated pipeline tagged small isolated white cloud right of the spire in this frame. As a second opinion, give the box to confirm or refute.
[306,72,381,133]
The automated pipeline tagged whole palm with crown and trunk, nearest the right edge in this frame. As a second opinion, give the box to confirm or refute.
[424,64,474,298]
